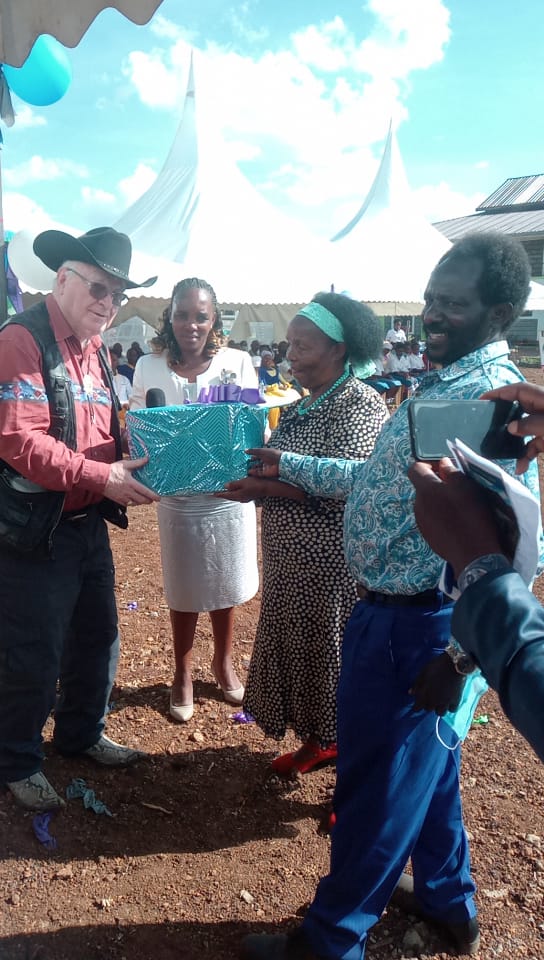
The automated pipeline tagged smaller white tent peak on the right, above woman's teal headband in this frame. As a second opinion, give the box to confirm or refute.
[332,125,451,304]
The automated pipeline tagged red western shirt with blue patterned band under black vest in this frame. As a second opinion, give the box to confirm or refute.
[0,295,116,510]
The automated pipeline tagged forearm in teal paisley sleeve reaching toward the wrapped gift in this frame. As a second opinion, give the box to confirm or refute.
[279,453,366,500]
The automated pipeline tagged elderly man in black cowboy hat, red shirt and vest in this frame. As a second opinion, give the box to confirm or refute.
[0,227,158,810]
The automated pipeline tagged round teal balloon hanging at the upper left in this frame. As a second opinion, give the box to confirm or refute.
[2,34,72,107]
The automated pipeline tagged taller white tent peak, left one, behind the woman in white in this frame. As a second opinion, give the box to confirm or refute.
[114,51,334,303]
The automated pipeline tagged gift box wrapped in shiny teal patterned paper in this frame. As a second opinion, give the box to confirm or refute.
[126,403,269,497]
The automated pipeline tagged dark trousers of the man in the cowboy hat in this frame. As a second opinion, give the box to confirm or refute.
[0,508,119,783]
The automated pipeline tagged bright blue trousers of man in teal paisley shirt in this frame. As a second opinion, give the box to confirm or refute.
[303,600,476,960]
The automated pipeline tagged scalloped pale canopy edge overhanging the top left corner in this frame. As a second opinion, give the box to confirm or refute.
[0,0,161,67]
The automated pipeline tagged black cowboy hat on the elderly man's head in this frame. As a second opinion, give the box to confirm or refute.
[34,227,157,289]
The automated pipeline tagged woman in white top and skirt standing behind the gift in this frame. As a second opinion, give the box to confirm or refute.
[130,278,259,721]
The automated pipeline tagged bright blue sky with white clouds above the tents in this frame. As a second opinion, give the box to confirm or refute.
[2,0,544,242]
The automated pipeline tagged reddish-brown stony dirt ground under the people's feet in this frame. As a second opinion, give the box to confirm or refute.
[0,371,544,960]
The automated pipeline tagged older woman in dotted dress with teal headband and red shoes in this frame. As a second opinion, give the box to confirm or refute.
[219,293,388,775]
